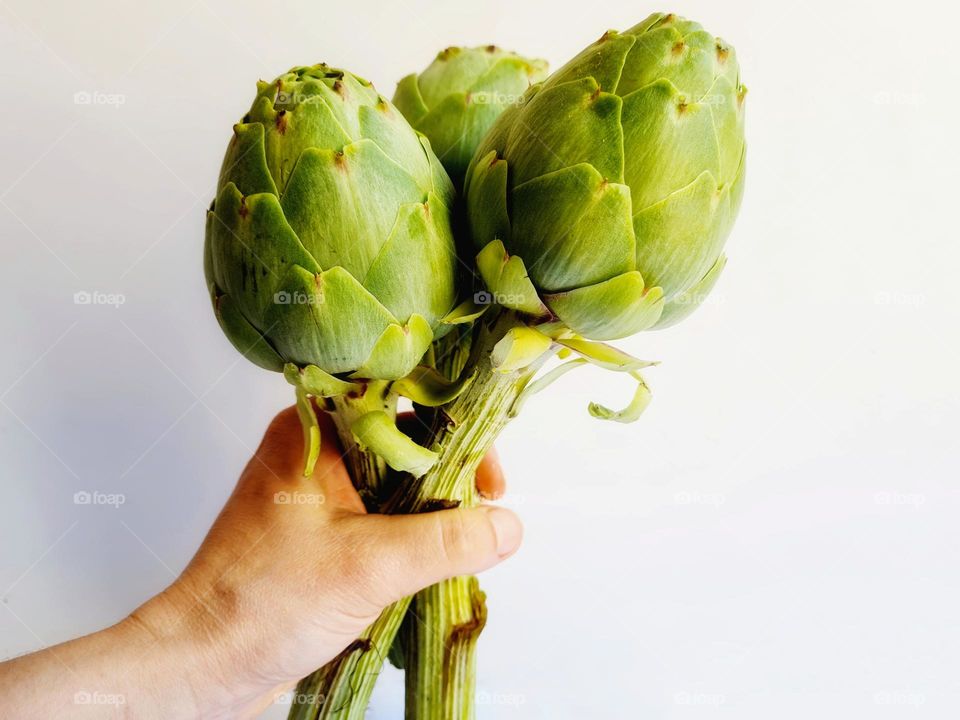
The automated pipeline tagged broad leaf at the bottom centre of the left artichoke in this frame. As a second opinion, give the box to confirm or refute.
[264,265,394,380]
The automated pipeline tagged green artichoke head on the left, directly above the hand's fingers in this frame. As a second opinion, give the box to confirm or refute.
[204,65,457,380]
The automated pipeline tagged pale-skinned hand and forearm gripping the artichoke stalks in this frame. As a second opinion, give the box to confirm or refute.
[0,408,523,720]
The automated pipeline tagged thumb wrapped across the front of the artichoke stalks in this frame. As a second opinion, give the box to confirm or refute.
[362,505,523,603]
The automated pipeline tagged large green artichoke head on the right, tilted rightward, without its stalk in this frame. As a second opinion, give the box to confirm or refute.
[466,14,746,340]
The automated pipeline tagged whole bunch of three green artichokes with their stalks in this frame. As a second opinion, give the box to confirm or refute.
[204,14,745,720]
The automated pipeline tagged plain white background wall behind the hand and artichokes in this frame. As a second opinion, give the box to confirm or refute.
[0,0,960,720]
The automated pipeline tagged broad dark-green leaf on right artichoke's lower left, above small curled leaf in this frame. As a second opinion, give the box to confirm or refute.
[511,163,636,292]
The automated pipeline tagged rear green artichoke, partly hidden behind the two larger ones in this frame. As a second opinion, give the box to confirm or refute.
[393,45,547,187]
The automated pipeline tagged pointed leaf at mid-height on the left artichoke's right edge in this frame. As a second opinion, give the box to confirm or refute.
[363,192,457,325]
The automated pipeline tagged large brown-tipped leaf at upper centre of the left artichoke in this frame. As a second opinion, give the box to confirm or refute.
[281,140,426,278]
